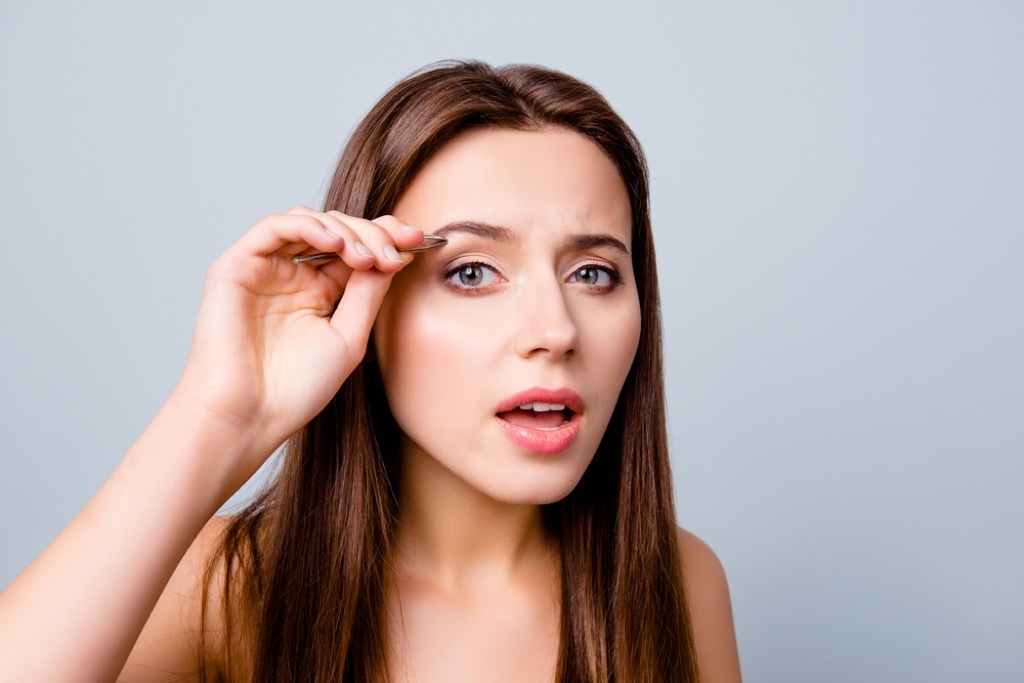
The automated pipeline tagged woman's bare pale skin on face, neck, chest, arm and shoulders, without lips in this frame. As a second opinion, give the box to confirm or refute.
[0,130,739,683]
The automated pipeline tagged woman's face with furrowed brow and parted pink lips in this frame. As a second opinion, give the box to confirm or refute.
[374,128,640,504]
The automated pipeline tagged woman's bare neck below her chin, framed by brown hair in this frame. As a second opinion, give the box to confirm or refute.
[395,447,552,592]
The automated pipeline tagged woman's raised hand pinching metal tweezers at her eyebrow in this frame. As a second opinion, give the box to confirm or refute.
[176,207,423,480]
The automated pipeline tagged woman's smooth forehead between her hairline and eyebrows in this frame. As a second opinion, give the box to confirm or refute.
[394,128,632,244]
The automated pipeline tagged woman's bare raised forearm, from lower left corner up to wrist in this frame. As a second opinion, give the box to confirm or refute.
[0,389,268,682]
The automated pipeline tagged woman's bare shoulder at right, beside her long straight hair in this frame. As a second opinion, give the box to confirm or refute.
[678,528,740,683]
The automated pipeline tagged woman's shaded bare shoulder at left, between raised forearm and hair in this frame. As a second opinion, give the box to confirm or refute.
[118,517,229,683]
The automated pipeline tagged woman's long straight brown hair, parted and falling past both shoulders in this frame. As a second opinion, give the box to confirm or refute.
[204,61,697,682]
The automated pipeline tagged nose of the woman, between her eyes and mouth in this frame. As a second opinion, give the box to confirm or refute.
[515,274,580,359]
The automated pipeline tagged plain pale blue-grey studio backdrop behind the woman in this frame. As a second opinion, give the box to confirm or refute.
[0,0,1024,682]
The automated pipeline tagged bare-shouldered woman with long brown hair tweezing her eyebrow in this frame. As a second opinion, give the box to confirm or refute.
[0,62,739,681]
